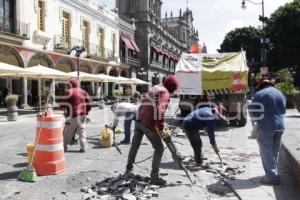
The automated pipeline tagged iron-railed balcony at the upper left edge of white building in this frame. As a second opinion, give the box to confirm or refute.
[0,16,30,39]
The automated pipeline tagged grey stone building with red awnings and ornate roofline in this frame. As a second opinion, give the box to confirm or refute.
[116,0,199,84]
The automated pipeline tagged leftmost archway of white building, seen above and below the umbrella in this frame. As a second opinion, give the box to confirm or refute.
[0,46,24,107]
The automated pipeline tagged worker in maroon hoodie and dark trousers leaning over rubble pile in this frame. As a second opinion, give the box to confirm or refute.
[126,76,179,185]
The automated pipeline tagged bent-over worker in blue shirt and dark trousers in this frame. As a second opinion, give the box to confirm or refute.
[182,102,226,165]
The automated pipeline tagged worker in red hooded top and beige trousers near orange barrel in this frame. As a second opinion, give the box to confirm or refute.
[60,78,92,152]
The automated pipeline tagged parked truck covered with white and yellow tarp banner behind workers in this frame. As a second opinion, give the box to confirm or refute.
[175,51,248,126]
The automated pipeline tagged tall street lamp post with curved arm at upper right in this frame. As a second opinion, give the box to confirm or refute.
[242,0,267,67]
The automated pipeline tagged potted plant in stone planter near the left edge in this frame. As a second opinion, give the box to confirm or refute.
[5,94,19,121]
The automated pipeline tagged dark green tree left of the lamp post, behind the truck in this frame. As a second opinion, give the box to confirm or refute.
[218,26,261,72]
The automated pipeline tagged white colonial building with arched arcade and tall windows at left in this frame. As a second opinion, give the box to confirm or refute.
[0,0,130,106]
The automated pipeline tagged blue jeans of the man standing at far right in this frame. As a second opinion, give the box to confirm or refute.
[257,128,283,181]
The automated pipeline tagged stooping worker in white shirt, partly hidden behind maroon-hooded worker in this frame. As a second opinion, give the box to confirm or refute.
[111,102,138,144]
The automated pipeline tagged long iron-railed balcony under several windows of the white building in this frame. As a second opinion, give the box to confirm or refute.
[54,35,114,60]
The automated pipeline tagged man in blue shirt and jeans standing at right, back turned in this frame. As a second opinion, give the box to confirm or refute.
[248,76,286,185]
